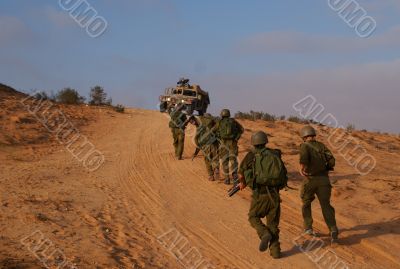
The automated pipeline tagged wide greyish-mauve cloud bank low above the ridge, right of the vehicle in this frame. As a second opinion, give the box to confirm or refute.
[202,59,400,132]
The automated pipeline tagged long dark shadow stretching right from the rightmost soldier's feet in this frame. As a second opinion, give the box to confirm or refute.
[340,218,400,245]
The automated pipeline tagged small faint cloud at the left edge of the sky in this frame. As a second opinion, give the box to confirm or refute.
[0,16,34,47]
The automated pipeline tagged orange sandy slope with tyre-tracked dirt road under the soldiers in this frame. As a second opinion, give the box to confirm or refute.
[0,105,400,269]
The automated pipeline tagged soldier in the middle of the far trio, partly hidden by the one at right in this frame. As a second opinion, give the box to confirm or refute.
[190,113,219,181]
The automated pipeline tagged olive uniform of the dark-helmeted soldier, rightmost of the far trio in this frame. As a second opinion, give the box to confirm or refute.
[217,118,244,181]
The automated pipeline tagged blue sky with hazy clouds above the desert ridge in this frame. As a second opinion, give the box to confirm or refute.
[0,0,400,133]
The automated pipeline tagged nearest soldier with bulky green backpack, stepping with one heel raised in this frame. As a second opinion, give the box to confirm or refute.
[239,131,287,259]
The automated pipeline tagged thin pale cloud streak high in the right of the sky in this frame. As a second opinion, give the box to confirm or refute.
[236,25,400,54]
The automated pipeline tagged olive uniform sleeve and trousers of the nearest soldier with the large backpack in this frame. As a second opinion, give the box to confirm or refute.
[239,149,281,257]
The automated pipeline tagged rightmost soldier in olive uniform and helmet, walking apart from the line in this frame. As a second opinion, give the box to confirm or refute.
[300,126,339,243]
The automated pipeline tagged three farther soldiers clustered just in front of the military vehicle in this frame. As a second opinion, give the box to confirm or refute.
[169,105,244,185]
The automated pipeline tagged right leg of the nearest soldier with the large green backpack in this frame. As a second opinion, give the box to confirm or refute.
[267,195,281,258]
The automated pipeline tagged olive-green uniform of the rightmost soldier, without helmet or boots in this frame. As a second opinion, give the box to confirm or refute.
[300,141,338,232]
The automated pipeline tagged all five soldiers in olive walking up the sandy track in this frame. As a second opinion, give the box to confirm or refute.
[169,105,339,259]
